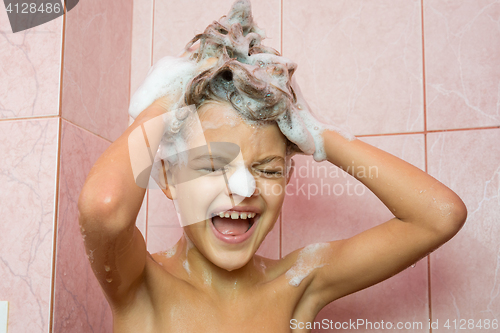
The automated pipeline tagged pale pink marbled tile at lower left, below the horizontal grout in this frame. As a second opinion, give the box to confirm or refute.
[0,118,59,333]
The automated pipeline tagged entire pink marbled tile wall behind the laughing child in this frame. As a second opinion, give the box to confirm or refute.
[0,0,500,333]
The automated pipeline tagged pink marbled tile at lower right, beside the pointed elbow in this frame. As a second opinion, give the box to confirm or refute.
[428,128,500,332]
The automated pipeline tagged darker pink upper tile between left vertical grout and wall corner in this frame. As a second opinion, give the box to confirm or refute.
[61,0,132,141]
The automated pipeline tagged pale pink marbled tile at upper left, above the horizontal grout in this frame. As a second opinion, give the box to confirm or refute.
[0,9,63,119]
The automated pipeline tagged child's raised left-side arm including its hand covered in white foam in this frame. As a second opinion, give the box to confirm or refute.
[78,52,217,306]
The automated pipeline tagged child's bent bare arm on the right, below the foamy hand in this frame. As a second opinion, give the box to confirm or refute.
[300,130,467,306]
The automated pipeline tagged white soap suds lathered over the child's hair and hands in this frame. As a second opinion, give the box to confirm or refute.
[129,0,354,161]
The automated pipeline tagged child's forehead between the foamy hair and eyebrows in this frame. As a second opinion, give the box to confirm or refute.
[198,102,287,157]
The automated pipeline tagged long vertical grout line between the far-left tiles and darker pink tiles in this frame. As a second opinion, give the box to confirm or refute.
[47,1,67,333]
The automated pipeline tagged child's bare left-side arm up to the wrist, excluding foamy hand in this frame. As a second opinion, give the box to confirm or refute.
[78,99,166,305]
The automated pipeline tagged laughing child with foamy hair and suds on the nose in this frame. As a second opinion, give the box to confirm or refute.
[78,1,467,332]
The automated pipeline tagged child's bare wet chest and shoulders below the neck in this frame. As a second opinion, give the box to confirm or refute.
[115,260,316,333]
